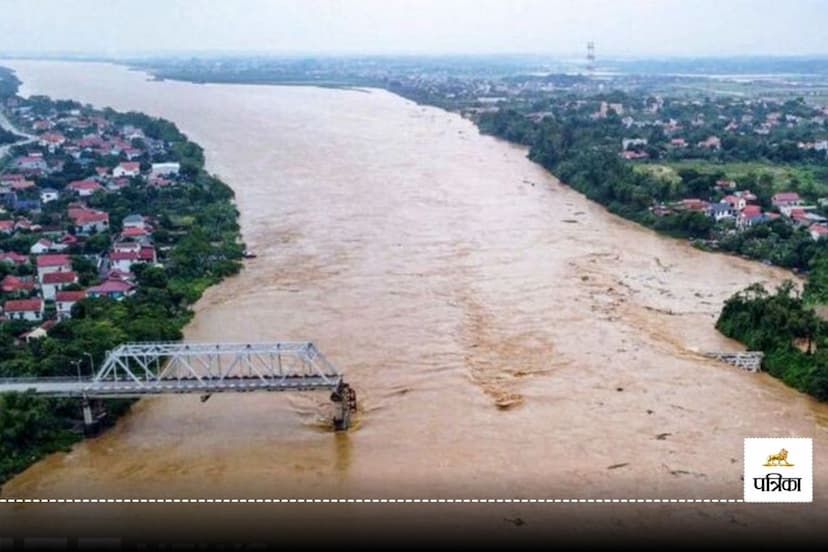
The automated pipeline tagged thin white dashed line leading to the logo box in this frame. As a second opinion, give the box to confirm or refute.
[0,498,744,504]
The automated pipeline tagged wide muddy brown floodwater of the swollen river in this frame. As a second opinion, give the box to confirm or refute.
[3,61,828,533]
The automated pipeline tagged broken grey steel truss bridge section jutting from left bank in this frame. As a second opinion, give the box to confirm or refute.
[0,342,356,429]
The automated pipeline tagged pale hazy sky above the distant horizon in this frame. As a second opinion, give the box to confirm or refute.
[0,0,828,57]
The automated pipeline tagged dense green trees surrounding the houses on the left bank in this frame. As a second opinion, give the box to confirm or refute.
[0,73,244,482]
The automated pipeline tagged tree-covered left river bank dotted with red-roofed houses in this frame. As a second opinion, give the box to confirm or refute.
[0,72,244,483]
